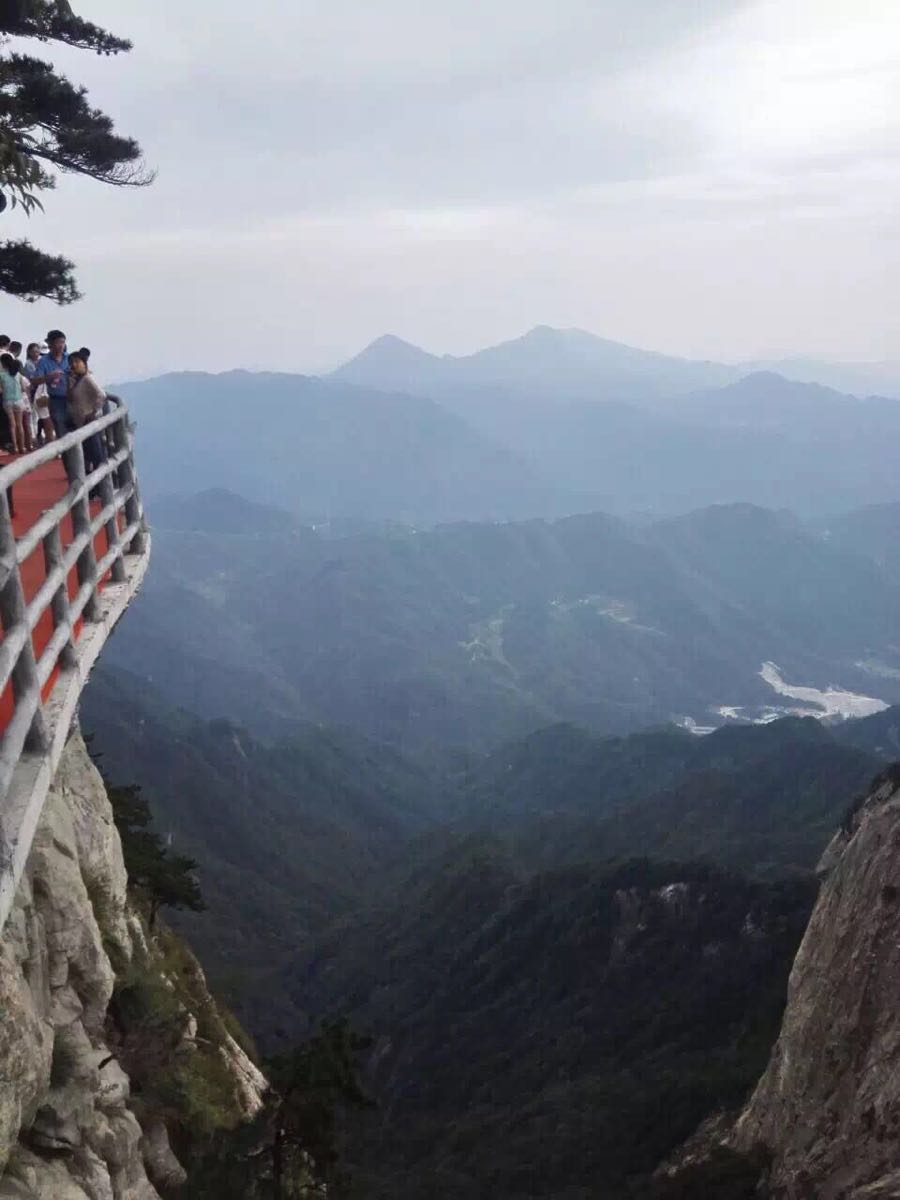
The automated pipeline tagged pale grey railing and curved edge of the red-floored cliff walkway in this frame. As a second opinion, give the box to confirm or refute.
[0,406,150,929]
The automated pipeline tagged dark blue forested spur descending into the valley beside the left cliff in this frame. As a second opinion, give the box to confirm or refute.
[84,670,448,1022]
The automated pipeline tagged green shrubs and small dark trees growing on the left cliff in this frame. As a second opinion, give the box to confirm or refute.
[97,753,371,1185]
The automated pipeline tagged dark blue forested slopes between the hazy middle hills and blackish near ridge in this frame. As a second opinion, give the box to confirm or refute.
[83,668,900,1044]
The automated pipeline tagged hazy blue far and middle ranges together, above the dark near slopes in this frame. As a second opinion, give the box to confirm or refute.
[109,326,900,745]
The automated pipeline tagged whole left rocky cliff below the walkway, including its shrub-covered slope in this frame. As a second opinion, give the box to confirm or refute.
[0,734,265,1200]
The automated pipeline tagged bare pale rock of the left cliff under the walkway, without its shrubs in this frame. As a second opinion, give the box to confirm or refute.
[0,734,265,1200]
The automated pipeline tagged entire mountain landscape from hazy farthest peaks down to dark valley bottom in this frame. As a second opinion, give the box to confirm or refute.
[84,328,900,1200]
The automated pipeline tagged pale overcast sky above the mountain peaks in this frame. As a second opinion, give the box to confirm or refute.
[0,0,900,379]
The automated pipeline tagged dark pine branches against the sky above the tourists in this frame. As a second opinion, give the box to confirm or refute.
[0,0,152,304]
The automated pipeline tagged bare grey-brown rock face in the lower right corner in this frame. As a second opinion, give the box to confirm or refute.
[728,767,900,1200]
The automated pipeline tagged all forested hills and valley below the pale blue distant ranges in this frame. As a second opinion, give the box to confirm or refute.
[77,465,900,1200]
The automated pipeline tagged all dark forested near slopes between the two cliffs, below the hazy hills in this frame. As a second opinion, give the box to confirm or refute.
[77,614,900,1200]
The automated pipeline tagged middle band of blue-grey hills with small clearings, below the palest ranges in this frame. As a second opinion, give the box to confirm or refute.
[97,493,900,748]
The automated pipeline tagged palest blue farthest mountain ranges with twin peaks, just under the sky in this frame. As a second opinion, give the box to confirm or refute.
[121,326,900,526]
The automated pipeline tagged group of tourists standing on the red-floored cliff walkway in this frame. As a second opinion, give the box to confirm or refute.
[0,329,107,456]
